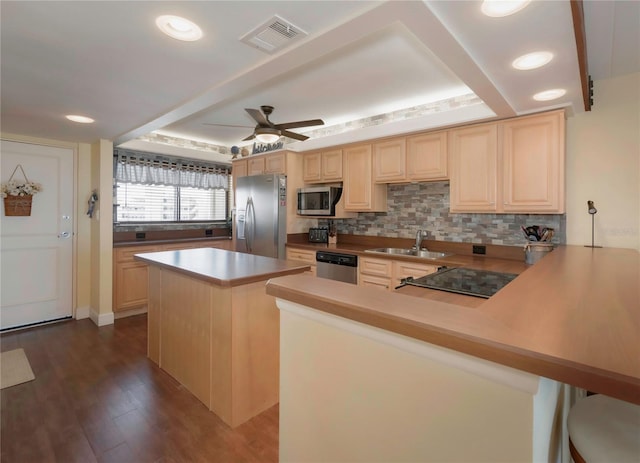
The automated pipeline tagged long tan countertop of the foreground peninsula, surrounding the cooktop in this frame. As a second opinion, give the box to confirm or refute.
[267,246,640,404]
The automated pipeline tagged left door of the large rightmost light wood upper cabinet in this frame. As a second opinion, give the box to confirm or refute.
[449,123,498,212]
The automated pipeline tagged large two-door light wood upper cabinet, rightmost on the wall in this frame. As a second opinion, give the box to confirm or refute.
[449,111,565,214]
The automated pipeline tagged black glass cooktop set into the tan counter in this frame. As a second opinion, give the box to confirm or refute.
[403,267,518,299]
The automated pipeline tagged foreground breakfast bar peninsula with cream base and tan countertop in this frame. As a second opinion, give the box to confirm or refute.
[267,246,640,461]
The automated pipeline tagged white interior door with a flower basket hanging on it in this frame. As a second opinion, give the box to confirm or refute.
[0,140,74,330]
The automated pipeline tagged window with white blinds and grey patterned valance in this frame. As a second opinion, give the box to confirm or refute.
[114,153,231,223]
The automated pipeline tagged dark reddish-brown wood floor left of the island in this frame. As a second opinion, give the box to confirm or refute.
[0,315,278,463]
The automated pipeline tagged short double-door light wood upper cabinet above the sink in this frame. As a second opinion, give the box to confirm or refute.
[373,131,448,183]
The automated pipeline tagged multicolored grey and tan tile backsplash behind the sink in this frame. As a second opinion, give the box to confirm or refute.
[319,182,566,246]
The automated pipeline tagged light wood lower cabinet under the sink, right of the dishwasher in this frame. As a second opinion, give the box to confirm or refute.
[358,257,438,291]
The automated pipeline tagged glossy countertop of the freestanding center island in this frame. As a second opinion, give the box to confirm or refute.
[135,248,310,287]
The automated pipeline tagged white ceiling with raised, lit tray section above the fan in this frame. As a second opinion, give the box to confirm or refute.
[0,0,640,159]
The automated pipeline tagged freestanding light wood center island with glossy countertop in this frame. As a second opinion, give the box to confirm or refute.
[136,248,309,427]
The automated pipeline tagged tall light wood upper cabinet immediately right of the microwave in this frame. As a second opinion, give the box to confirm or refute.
[342,144,387,212]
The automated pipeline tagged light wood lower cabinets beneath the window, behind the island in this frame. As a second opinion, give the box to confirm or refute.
[113,240,231,315]
